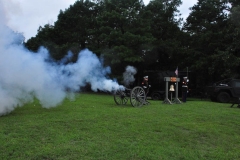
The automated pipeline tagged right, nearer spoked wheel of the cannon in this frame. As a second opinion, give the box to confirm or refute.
[130,87,146,107]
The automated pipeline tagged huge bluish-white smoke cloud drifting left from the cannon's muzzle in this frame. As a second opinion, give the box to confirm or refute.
[0,24,123,115]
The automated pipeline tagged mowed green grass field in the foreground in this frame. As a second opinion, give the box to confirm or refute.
[0,93,240,160]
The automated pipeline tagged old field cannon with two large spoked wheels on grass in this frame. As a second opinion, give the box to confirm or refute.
[114,86,149,107]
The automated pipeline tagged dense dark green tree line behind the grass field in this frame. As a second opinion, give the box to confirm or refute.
[25,0,240,85]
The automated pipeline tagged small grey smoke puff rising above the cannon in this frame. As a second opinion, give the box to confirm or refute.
[123,66,137,86]
